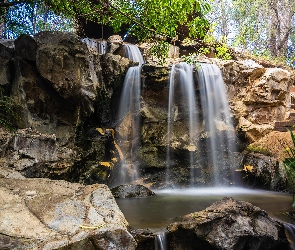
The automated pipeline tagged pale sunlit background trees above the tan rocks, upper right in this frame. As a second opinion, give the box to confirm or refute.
[210,0,295,66]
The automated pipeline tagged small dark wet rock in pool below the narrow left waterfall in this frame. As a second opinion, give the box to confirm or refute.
[111,184,155,198]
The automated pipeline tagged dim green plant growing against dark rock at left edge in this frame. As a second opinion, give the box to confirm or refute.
[0,88,19,132]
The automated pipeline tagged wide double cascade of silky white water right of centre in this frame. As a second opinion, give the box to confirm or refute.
[166,63,236,186]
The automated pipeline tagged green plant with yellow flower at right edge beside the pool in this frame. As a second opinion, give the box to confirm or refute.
[283,130,295,206]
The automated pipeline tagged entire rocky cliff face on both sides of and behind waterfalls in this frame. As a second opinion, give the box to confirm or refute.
[0,32,294,188]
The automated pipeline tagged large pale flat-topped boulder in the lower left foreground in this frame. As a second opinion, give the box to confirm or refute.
[0,173,136,250]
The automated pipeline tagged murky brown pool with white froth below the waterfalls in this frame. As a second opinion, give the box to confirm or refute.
[116,187,295,230]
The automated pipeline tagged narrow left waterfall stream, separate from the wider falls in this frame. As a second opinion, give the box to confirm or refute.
[116,44,144,184]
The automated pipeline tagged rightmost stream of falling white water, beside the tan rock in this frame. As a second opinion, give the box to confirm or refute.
[198,64,236,185]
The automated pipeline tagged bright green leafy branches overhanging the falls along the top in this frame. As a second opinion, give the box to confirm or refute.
[0,0,210,40]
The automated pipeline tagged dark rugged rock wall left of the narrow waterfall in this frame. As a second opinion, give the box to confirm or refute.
[0,32,132,183]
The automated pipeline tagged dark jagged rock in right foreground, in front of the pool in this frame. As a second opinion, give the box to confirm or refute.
[167,197,288,250]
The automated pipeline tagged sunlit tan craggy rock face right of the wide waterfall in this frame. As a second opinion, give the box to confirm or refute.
[214,60,295,142]
